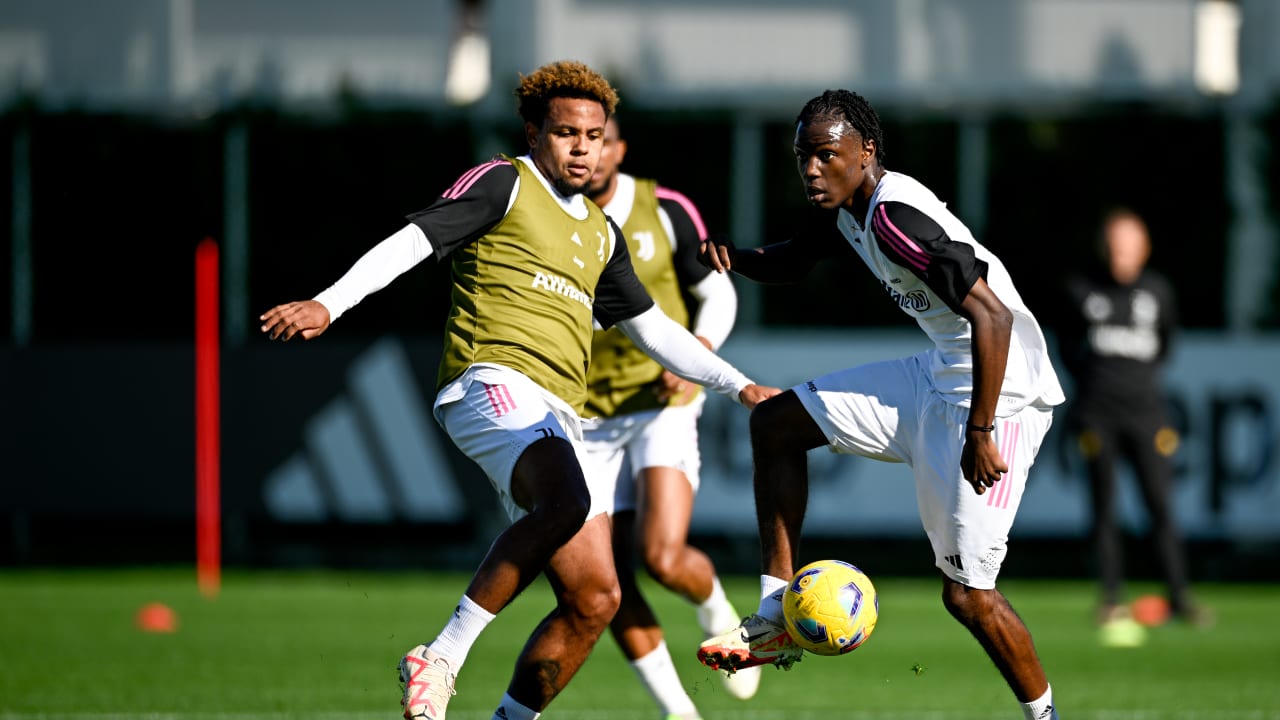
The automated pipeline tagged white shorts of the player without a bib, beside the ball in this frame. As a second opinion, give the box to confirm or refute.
[791,354,1053,589]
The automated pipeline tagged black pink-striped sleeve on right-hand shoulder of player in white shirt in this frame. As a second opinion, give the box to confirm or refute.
[872,201,987,311]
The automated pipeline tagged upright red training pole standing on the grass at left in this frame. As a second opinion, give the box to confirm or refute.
[196,237,221,597]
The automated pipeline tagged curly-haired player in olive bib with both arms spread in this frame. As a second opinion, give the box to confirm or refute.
[261,61,778,720]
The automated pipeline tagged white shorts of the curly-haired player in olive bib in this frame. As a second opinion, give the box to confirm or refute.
[435,364,613,523]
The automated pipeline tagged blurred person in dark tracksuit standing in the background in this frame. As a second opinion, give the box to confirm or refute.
[1061,208,1207,646]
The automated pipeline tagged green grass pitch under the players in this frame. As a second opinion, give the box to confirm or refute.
[0,569,1280,720]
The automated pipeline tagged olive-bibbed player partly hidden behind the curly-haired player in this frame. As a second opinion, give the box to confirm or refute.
[584,117,760,719]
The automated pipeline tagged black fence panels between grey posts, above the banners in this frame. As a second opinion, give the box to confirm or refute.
[0,101,1280,343]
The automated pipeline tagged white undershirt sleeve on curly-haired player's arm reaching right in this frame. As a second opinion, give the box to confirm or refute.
[618,305,753,401]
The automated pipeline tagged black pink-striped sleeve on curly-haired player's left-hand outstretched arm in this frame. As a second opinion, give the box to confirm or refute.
[407,160,520,260]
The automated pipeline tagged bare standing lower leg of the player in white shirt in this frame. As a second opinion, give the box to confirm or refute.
[942,577,1048,702]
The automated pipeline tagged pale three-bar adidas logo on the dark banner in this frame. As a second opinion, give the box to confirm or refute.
[262,338,467,523]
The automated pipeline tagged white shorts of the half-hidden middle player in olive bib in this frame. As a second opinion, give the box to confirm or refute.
[582,392,707,512]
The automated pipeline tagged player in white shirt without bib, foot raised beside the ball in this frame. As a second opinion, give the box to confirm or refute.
[699,90,1064,720]
